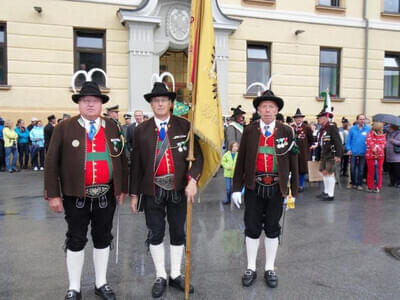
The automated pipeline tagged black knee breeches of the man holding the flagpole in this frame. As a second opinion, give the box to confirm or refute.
[143,191,187,246]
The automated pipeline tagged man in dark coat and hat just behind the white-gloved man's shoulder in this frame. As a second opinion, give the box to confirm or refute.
[292,108,314,192]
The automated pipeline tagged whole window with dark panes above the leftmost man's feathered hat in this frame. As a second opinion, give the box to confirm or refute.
[74,29,106,87]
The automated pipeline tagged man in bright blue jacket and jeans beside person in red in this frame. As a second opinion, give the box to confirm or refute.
[346,114,371,191]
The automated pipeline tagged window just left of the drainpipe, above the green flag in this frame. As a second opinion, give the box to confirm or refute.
[319,48,340,97]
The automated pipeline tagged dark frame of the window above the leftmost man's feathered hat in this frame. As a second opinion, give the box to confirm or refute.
[74,27,107,88]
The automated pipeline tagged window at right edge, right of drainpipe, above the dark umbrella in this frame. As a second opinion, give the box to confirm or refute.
[383,53,400,98]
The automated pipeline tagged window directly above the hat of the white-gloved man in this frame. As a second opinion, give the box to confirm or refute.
[247,45,271,94]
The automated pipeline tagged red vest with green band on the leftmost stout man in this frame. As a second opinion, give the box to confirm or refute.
[85,126,112,185]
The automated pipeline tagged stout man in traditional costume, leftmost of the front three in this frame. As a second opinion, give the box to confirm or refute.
[44,81,128,300]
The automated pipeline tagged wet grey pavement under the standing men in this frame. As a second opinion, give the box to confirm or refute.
[0,171,400,300]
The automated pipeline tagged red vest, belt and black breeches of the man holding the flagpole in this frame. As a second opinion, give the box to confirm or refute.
[143,130,186,246]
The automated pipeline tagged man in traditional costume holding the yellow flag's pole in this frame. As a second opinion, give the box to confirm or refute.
[129,82,203,298]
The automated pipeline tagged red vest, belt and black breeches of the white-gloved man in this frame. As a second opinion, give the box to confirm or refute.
[244,130,283,239]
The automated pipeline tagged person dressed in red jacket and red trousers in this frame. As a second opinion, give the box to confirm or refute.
[365,122,386,193]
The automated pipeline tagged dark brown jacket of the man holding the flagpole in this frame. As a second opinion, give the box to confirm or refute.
[129,116,203,196]
